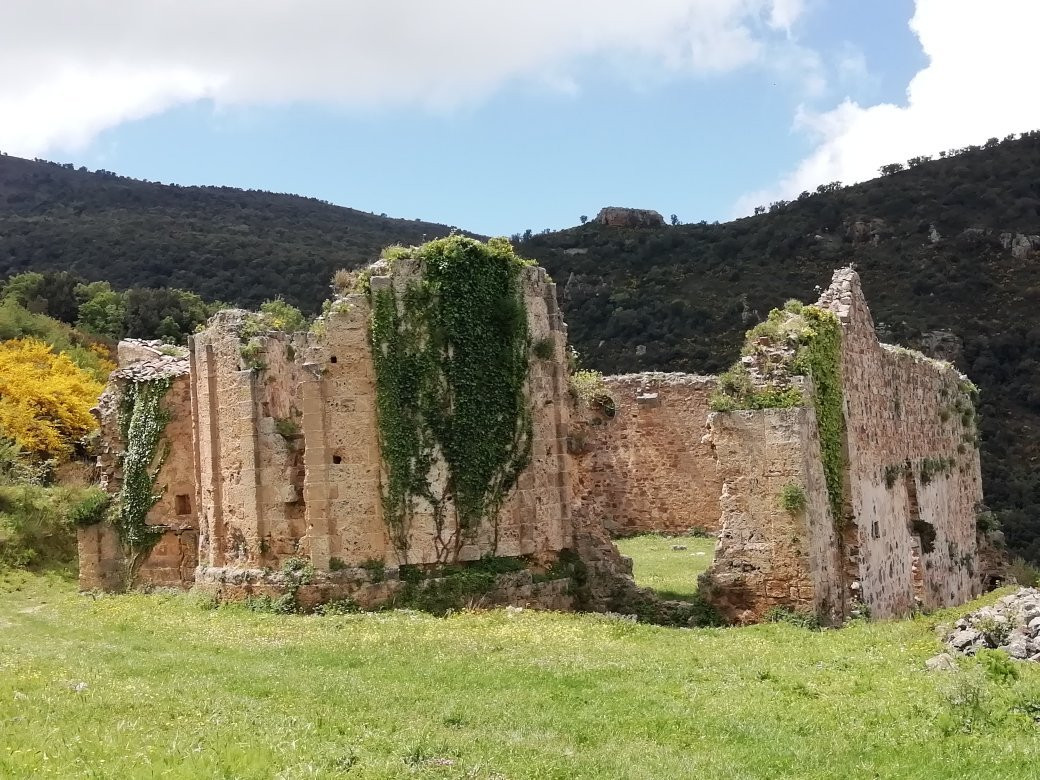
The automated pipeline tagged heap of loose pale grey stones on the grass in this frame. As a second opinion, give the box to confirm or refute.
[946,588,1040,661]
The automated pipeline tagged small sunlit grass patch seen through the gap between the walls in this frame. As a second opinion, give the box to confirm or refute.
[615,534,716,600]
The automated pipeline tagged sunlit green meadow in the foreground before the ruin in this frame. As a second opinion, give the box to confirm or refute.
[0,573,1040,780]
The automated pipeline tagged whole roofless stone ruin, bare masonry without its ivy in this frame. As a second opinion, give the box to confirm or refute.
[79,250,1000,624]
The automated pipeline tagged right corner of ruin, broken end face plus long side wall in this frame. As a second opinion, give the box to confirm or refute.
[709,268,985,621]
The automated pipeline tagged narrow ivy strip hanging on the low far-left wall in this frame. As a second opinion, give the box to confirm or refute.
[113,376,172,587]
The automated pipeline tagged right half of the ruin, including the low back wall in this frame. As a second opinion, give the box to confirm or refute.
[572,268,1003,624]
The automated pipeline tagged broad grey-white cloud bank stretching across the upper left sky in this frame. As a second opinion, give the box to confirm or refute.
[0,0,803,154]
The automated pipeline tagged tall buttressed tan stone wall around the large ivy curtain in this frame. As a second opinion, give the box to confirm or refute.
[191,254,573,603]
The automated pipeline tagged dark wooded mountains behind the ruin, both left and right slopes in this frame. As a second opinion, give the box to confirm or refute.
[0,133,1040,560]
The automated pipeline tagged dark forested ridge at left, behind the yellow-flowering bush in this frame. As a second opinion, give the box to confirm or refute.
[0,155,450,311]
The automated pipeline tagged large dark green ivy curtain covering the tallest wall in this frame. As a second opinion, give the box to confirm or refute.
[371,235,531,561]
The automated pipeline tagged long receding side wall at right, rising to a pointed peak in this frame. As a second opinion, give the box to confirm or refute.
[821,268,982,617]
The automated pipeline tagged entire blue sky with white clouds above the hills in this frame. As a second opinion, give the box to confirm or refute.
[0,0,1040,235]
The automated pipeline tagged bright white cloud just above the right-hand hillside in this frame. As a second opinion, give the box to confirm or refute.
[735,0,1040,214]
